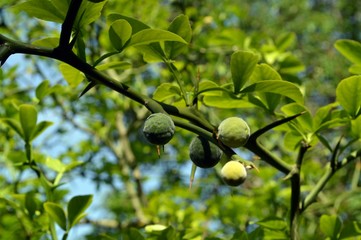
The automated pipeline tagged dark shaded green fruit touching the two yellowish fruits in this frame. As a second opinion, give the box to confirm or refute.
[189,136,222,168]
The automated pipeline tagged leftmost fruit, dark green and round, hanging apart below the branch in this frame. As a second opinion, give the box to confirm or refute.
[143,113,175,145]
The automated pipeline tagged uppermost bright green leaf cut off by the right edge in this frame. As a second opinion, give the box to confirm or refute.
[334,39,361,64]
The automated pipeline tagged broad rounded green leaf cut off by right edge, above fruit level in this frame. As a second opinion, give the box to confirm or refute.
[336,76,361,118]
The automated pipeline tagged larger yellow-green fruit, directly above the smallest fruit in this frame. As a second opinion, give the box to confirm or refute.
[217,117,250,148]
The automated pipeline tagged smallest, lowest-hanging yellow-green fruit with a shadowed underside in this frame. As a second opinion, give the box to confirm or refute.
[221,160,247,187]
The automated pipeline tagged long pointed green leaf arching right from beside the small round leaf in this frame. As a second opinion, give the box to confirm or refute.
[127,29,187,47]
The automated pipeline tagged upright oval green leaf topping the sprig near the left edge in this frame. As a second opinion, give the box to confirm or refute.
[19,104,38,142]
